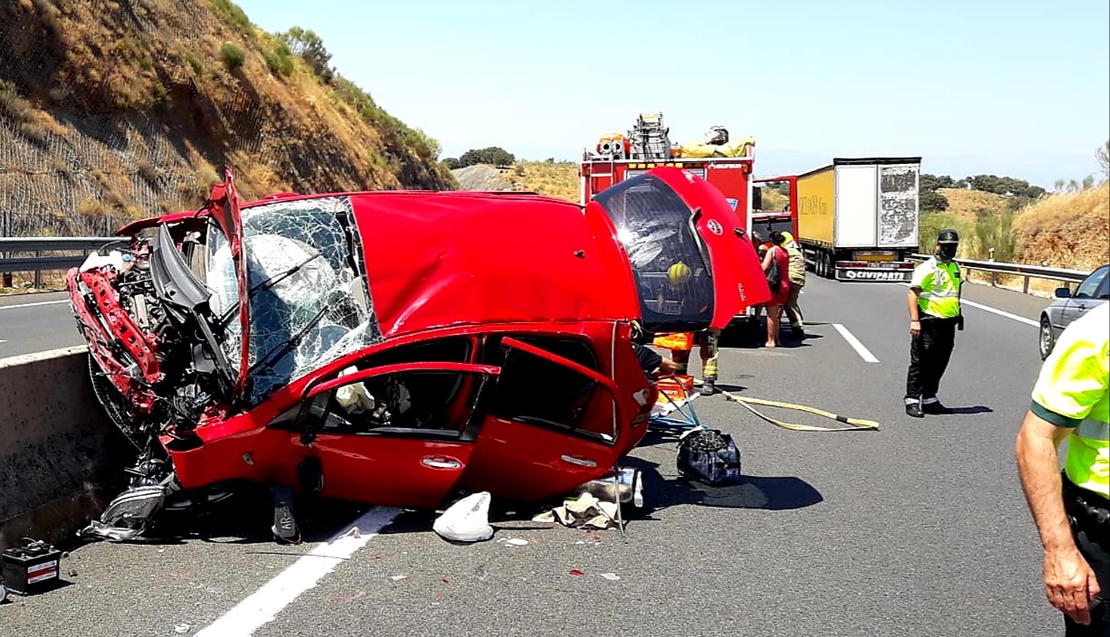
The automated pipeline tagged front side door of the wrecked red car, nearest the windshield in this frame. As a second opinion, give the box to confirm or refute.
[290,362,500,508]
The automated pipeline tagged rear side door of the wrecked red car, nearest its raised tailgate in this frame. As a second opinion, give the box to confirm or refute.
[461,336,627,502]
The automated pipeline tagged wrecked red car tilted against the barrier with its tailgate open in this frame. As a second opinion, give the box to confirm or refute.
[67,169,769,539]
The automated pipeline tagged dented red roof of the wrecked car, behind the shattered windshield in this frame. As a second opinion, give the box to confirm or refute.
[352,192,637,338]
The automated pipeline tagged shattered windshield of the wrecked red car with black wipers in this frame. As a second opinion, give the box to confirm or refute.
[206,196,382,404]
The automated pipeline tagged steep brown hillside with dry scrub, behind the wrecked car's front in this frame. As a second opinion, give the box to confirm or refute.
[0,0,456,235]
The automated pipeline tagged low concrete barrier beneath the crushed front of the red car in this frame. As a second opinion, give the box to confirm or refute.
[0,347,130,550]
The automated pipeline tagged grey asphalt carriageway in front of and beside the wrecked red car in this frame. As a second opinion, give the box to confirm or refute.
[0,277,1062,637]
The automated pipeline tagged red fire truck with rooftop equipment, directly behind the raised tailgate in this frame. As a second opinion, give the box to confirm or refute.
[578,113,781,320]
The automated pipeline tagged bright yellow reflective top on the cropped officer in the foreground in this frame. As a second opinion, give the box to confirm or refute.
[1030,303,1110,498]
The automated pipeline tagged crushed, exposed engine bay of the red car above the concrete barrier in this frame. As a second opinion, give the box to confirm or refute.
[70,226,234,463]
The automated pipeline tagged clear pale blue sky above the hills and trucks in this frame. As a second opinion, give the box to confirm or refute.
[239,0,1110,188]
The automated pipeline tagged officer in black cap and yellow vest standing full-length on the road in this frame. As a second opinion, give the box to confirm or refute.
[906,229,963,418]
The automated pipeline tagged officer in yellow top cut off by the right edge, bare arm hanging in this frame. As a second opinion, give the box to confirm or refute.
[1016,303,1110,637]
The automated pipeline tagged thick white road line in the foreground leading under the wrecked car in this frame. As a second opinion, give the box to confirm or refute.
[196,508,401,637]
